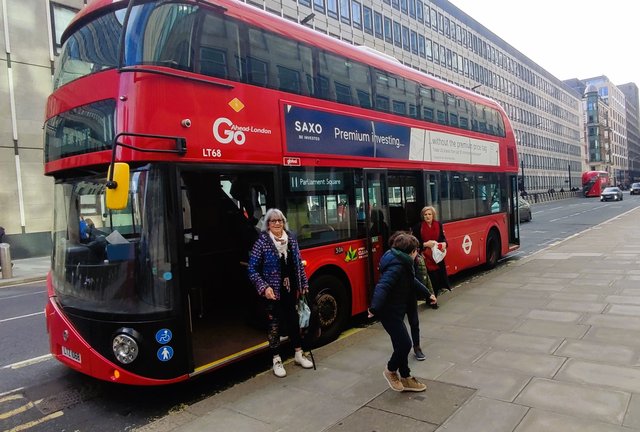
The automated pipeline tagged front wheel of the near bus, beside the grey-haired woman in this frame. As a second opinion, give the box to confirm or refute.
[310,275,351,345]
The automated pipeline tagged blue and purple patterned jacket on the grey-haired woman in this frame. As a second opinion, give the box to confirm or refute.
[249,231,309,300]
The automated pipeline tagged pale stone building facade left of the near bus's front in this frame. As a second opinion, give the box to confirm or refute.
[0,0,85,258]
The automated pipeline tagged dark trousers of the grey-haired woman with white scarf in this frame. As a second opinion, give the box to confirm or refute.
[265,288,302,356]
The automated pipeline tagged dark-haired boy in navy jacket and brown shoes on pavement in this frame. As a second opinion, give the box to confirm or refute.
[369,233,430,392]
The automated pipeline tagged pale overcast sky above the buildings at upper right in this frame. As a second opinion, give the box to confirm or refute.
[449,0,640,86]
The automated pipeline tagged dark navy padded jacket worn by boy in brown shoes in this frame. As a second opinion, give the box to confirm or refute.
[369,249,429,316]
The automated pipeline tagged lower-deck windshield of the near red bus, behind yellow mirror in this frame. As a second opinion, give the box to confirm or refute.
[52,168,174,314]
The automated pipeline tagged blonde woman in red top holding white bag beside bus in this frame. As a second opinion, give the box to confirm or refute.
[411,206,451,296]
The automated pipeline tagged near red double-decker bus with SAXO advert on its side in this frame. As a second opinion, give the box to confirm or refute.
[45,0,519,385]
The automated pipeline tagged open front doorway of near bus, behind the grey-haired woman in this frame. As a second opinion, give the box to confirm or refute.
[180,168,275,374]
